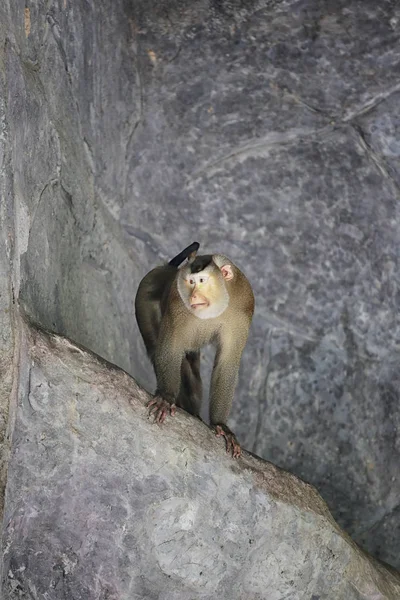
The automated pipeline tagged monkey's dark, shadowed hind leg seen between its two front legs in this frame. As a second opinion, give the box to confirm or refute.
[176,352,203,417]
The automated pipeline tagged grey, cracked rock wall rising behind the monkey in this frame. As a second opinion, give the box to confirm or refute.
[0,0,400,568]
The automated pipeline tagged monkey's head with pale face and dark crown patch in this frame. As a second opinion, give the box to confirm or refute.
[178,254,234,319]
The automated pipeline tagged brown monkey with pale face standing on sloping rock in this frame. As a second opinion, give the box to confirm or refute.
[135,242,255,458]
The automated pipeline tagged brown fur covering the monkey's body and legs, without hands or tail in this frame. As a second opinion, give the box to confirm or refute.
[135,248,254,425]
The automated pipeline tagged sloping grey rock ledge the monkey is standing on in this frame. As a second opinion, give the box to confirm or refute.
[1,329,400,600]
